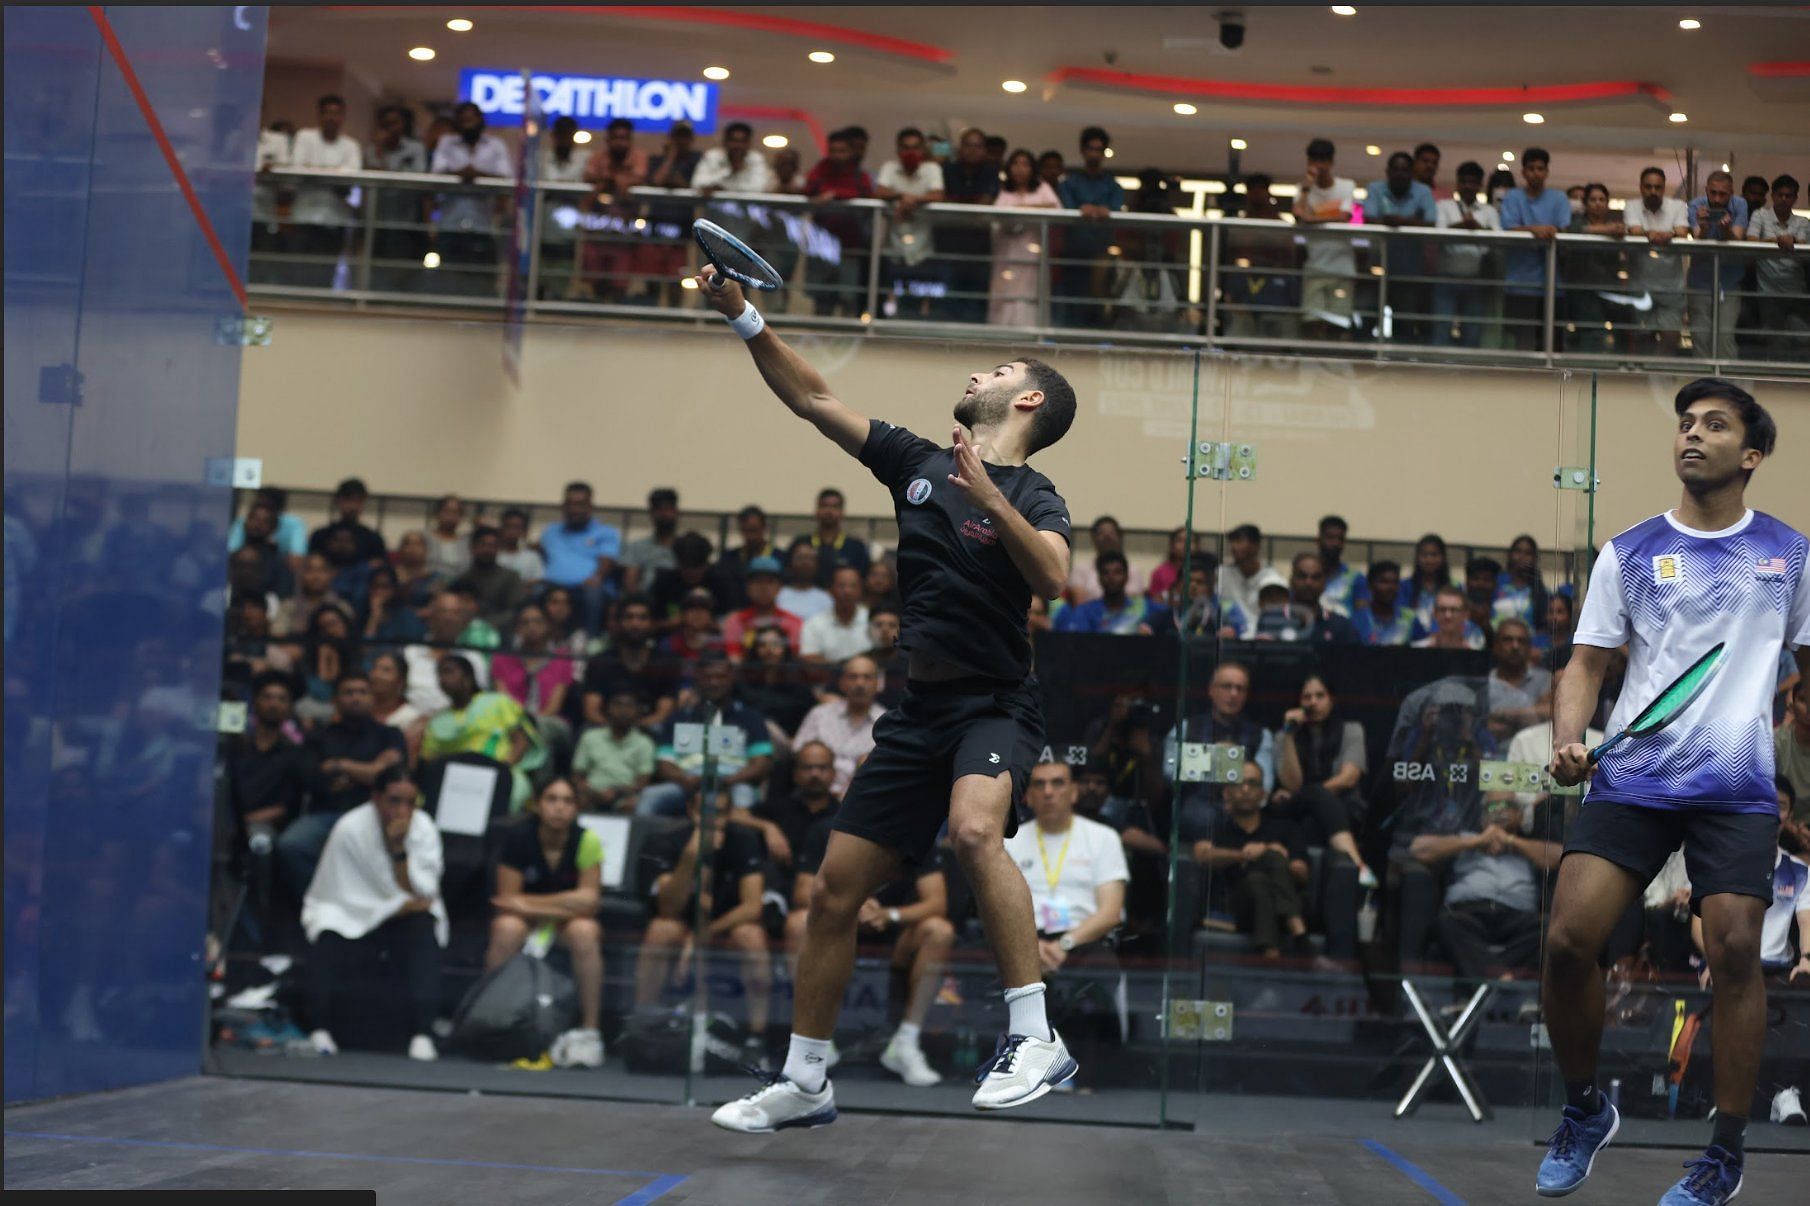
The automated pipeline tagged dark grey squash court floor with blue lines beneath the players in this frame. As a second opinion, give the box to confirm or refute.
[5,1077,1810,1206]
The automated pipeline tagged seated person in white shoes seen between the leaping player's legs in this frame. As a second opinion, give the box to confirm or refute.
[786,817,956,1088]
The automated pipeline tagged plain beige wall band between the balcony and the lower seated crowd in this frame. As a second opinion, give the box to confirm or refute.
[239,306,1810,549]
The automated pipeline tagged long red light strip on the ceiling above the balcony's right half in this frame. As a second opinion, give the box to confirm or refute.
[1048,67,1671,107]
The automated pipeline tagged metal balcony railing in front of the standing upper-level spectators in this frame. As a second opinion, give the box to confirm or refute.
[252,170,1810,373]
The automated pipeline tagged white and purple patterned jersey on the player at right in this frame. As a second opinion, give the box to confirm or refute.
[1573,511,1810,813]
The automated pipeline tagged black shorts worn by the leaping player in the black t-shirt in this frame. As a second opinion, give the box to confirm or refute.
[831,677,1043,866]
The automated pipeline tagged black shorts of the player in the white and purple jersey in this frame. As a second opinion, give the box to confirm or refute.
[1566,800,1779,913]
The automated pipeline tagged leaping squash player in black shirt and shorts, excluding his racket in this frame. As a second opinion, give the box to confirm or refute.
[697,272,1075,1132]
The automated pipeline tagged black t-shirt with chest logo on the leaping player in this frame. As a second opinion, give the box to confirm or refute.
[862,418,1072,681]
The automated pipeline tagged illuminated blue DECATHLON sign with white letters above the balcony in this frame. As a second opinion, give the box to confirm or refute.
[458,67,717,134]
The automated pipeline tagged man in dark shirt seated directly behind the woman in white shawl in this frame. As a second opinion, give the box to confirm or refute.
[277,666,409,893]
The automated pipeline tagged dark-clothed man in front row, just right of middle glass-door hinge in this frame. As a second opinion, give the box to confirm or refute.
[1193,762,1310,960]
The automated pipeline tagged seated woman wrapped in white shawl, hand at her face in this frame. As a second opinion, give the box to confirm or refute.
[302,766,449,1059]
